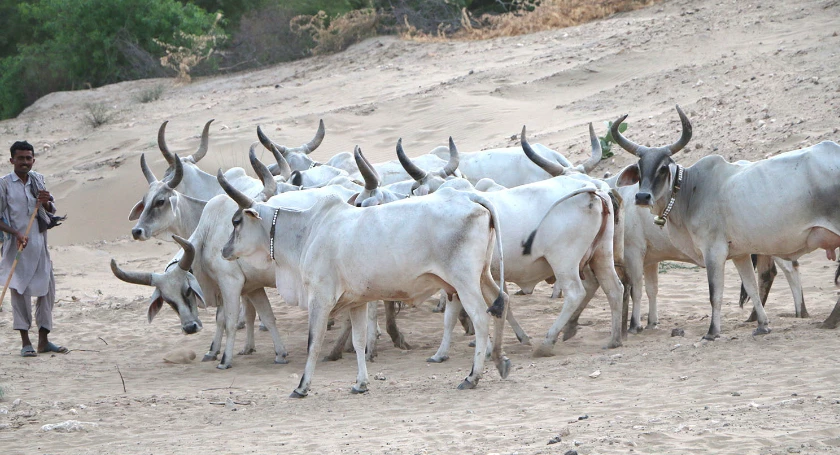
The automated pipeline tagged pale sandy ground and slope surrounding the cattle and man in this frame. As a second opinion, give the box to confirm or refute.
[0,0,840,454]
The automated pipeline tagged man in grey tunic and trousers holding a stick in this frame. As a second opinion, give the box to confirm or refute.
[0,141,68,357]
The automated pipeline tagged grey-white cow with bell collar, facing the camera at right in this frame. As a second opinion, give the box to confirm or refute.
[612,106,840,340]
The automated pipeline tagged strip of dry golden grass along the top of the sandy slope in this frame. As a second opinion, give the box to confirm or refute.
[401,0,661,41]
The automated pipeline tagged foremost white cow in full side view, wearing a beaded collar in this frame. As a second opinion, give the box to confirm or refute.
[219,173,510,398]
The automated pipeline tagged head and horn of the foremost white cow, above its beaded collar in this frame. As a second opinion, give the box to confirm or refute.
[216,169,269,261]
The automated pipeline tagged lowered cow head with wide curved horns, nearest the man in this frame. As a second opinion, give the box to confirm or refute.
[111,235,204,334]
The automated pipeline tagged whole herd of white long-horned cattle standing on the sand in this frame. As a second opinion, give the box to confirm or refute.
[111,106,840,397]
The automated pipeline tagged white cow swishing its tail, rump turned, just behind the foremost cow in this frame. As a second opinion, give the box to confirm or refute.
[402,128,623,356]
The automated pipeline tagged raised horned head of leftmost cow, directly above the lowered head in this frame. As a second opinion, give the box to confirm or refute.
[128,154,184,240]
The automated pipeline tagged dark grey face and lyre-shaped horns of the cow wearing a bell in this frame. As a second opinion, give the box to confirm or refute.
[611,106,691,210]
